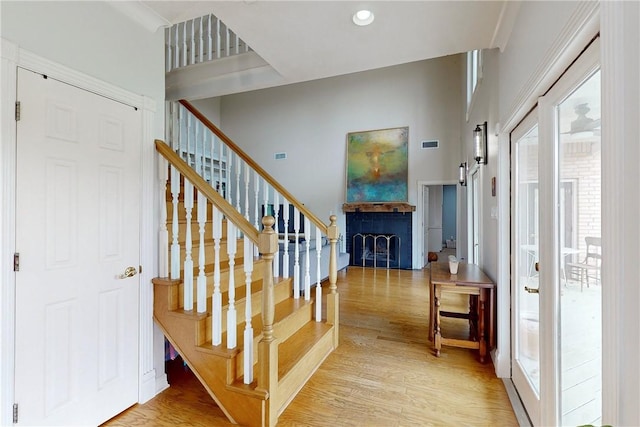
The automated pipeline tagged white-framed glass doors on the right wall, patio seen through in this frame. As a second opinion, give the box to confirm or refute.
[511,40,606,425]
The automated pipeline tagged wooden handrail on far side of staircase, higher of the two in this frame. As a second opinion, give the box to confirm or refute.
[179,99,327,235]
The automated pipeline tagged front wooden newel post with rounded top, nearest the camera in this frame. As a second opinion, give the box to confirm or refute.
[258,216,278,426]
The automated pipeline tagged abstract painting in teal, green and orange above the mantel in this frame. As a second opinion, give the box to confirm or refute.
[347,127,409,203]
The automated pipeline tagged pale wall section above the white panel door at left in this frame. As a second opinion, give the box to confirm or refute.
[0,1,164,126]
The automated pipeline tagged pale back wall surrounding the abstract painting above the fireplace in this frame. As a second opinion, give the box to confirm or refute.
[214,55,461,268]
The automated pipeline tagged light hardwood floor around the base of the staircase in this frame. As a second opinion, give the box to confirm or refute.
[105,267,518,427]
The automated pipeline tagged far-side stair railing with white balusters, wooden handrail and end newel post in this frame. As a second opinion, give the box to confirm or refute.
[166,100,339,347]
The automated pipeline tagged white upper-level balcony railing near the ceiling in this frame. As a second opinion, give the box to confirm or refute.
[165,14,251,72]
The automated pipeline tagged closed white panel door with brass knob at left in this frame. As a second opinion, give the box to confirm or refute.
[15,69,142,425]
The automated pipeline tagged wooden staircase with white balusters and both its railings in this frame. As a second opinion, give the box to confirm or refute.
[153,103,338,426]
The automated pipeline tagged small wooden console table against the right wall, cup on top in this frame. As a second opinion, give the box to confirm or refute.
[429,262,495,363]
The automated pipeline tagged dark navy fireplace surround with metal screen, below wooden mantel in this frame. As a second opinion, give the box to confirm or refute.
[346,212,412,269]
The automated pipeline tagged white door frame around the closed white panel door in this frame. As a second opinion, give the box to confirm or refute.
[0,39,160,425]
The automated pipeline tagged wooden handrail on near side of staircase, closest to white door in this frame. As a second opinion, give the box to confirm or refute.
[156,139,260,244]
